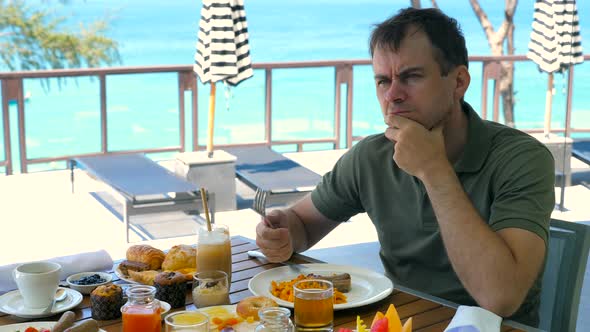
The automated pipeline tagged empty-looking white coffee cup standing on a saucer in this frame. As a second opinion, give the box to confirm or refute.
[13,262,61,309]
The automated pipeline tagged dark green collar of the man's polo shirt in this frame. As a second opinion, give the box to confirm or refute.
[454,102,491,173]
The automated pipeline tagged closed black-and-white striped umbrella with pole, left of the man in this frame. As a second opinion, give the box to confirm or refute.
[194,0,253,157]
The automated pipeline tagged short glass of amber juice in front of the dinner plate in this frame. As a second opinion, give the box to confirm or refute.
[293,279,334,331]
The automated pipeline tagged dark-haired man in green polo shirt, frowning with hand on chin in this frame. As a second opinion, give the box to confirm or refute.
[256,8,555,326]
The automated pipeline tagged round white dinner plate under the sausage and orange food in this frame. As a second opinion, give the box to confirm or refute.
[248,264,393,310]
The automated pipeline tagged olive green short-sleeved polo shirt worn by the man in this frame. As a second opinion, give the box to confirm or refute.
[311,103,555,325]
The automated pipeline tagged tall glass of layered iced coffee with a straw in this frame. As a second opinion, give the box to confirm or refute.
[197,224,231,285]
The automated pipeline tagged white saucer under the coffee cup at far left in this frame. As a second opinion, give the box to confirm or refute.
[0,287,82,318]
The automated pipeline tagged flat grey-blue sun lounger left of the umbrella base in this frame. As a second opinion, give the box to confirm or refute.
[70,154,215,242]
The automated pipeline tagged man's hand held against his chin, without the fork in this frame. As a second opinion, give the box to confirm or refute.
[385,115,449,180]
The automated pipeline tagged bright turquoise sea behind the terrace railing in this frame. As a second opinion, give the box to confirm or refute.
[0,0,590,171]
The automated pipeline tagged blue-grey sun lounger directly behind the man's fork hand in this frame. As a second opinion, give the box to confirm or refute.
[224,146,321,206]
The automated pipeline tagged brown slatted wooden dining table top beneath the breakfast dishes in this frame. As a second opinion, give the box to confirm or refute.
[0,236,526,332]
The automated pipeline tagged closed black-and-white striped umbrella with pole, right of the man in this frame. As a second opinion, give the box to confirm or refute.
[527,0,584,136]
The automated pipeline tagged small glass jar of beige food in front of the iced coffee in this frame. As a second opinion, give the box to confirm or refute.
[193,271,229,308]
